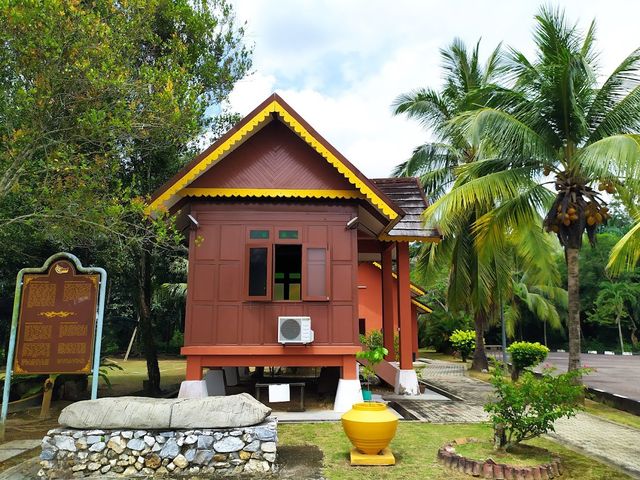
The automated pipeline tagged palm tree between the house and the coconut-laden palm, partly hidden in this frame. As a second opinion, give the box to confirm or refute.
[393,39,502,370]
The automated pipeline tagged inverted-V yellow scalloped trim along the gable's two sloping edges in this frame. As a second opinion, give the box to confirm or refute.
[145,100,398,220]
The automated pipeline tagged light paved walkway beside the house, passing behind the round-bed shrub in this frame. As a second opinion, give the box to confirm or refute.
[397,355,640,479]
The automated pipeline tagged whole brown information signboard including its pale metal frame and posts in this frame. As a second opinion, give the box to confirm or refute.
[0,253,107,440]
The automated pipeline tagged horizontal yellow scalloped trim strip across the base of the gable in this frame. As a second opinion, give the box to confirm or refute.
[178,188,364,198]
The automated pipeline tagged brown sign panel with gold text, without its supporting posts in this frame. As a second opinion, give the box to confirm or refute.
[13,259,100,375]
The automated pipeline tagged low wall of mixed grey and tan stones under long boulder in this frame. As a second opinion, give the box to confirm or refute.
[38,417,278,478]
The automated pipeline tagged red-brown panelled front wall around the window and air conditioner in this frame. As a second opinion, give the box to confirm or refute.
[185,201,359,346]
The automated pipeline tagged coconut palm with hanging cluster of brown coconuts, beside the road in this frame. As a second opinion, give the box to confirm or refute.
[430,7,640,370]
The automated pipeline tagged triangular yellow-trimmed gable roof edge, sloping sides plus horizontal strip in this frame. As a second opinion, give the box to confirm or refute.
[146,93,404,222]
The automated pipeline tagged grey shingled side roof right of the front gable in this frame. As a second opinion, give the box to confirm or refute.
[372,177,441,241]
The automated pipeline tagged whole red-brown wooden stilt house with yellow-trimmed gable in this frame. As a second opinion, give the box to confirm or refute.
[148,94,440,411]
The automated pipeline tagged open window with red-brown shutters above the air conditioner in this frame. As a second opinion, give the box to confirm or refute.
[245,239,330,302]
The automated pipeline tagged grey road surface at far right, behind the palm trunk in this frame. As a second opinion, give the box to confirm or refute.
[544,352,640,401]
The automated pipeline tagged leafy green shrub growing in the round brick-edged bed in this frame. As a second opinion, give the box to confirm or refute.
[484,367,587,449]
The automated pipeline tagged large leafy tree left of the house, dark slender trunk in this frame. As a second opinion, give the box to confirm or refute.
[0,0,251,393]
